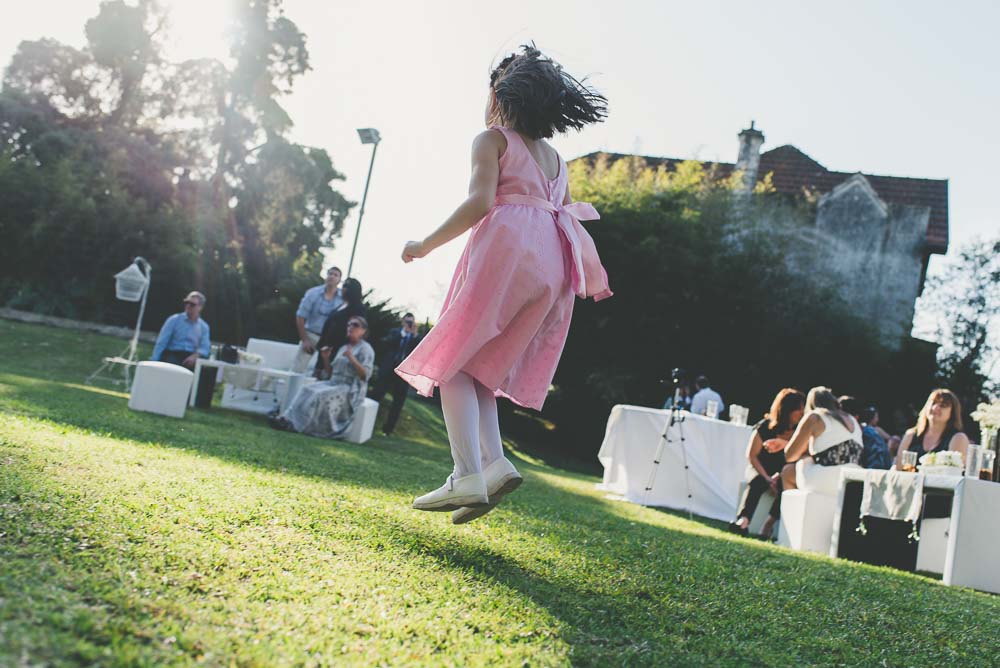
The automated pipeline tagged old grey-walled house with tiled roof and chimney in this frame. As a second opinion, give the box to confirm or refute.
[578,123,948,346]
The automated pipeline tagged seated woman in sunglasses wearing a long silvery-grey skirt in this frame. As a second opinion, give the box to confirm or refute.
[270,316,375,438]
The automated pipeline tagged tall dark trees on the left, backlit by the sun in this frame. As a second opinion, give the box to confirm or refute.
[0,0,353,343]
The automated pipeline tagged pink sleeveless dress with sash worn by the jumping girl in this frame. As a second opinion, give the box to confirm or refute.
[396,122,612,409]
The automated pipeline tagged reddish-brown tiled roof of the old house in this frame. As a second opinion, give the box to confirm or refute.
[579,144,948,253]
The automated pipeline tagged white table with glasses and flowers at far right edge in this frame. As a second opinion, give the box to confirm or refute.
[830,469,1000,594]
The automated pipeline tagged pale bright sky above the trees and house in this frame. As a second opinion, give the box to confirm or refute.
[0,0,1000,332]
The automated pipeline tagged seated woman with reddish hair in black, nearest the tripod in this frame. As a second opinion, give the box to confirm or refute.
[729,387,806,538]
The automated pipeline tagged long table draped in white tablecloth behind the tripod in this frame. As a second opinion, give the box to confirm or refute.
[597,405,752,521]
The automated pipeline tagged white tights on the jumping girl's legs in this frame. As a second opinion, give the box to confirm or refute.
[441,371,503,478]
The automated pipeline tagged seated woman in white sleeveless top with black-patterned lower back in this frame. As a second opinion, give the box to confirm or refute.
[781,387,864,496]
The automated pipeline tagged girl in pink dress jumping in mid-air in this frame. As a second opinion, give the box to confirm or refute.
[396,45,612,524]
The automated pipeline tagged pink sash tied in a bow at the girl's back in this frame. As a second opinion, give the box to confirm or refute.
[495,193,614,302]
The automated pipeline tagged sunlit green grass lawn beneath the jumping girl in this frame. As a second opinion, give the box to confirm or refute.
[0,321,1000,666]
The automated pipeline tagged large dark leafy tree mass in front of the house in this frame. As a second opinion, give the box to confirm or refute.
[544,158,916,456]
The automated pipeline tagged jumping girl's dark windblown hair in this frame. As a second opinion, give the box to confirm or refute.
[490,44,608,139]
